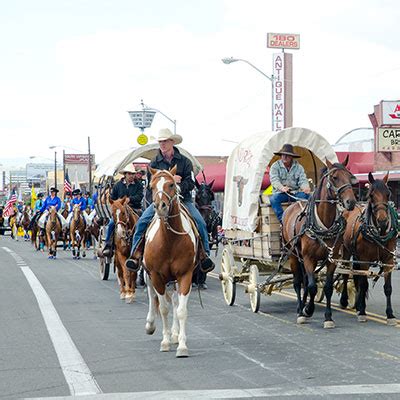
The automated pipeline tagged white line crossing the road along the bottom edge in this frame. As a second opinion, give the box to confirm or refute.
[30,383,400,400]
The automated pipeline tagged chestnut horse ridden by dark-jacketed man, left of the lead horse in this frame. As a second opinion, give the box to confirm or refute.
[110,196,139,303]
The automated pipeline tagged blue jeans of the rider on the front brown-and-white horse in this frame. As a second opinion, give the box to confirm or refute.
[131,201,210,256]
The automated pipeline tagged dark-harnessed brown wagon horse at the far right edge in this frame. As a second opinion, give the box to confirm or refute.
[340,172,399,325]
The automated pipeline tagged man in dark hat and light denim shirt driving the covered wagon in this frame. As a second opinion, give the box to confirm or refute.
[269,143,310,223]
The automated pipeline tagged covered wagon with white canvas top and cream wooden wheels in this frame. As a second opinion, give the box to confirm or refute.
[220,128,338,312]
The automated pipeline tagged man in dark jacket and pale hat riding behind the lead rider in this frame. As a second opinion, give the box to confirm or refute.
[103,164,143,257]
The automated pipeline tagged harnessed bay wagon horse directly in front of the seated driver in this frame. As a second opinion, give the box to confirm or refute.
[281,156,357,328]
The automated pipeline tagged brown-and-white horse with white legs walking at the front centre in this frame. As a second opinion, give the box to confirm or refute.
[143,166,198,357]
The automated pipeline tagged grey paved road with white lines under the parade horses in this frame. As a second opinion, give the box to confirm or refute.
[0,237,400,399]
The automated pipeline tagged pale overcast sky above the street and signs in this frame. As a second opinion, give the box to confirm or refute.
[0,0,400,163]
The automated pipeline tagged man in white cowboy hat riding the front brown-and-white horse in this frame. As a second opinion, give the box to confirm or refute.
[125,129,215,272]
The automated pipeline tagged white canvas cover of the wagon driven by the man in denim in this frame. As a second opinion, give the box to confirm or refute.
[223,128,338,232]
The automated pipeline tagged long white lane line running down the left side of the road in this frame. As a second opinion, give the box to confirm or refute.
[3,247,102,396]
